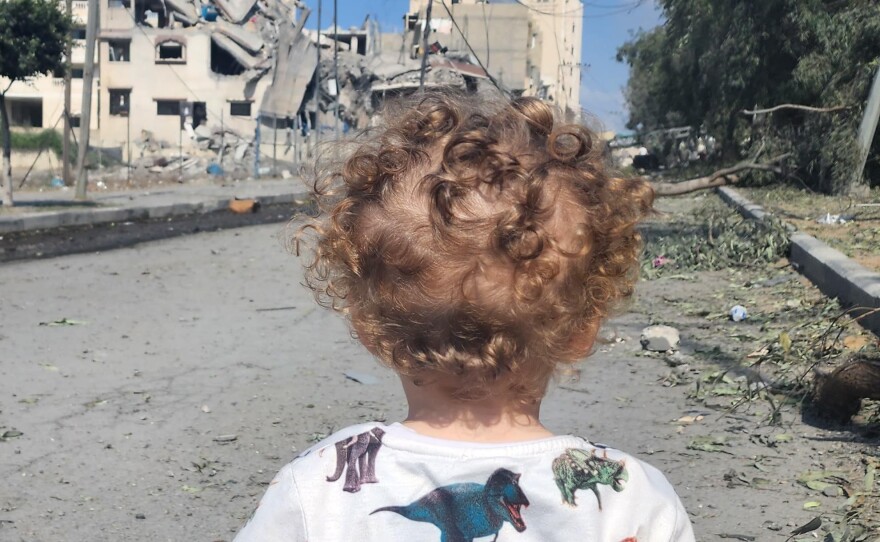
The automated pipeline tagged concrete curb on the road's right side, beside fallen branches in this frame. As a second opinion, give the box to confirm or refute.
[716,186,880,335]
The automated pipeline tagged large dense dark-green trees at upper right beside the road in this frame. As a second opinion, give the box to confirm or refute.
[617,0,880,196]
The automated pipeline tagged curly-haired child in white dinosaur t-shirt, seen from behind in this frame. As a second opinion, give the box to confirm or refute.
[236,92,694,542]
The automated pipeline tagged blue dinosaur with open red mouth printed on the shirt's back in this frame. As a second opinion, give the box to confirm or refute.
[370,469,529,542]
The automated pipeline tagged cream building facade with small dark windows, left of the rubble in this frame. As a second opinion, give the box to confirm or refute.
[0,0,316,164]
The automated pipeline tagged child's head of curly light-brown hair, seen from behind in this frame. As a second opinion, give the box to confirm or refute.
[302,92,653,401]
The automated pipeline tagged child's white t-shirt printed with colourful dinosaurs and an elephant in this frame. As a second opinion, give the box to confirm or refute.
[235,423,694,542]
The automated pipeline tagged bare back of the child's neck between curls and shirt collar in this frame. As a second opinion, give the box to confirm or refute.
[401,378,553,442]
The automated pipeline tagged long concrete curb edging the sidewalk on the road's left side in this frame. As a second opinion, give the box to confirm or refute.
[0,193,306,235]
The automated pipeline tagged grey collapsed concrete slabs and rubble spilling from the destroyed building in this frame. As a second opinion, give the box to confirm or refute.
[103,0,487,184]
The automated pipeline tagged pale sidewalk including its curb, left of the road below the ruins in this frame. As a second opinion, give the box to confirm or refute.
[0,178,305,235]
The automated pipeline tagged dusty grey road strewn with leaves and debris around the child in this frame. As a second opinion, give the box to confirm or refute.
[0,195,880,542]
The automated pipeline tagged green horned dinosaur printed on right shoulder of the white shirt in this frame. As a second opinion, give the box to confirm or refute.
[553,448,629,510]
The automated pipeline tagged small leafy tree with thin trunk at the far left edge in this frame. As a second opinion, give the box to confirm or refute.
[0,0,71,205]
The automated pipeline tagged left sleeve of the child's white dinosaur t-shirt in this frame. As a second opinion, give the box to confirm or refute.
[233,465,307,542]
